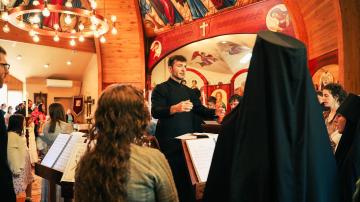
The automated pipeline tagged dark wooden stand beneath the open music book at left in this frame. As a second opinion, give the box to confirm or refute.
[35,163,74,202]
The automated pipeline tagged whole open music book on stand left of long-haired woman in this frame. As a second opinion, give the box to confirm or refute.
[41,132,87,181]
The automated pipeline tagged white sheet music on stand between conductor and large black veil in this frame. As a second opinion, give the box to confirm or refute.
[186,138,216,182]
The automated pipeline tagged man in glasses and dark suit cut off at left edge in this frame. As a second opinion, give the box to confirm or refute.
[0,46,16,202]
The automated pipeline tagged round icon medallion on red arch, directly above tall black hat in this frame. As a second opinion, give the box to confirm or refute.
[266,4,290,32]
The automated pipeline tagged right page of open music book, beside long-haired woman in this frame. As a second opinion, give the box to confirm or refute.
[61,137,87,182]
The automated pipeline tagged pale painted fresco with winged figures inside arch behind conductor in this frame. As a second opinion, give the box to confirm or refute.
[154,34,256,75]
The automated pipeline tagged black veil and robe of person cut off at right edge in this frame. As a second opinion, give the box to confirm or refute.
[335,93,360,202]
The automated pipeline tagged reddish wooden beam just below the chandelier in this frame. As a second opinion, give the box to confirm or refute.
[0,20,95,53]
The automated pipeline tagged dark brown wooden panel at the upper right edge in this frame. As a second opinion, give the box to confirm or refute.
[340,0,360,94]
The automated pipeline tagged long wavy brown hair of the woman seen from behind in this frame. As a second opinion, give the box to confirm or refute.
[75,84,150,202]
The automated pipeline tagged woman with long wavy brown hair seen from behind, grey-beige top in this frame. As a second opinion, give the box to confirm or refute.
[75,85,178,202]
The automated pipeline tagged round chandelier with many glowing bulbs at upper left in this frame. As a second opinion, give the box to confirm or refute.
[1,0,117,46]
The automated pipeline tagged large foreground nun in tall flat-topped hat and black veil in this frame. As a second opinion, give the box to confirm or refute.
[203,31,340,202]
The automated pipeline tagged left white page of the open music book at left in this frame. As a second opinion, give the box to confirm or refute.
[41,134,70,168]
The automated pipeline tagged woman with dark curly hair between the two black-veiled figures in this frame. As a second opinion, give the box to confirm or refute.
[322,83,347,152]
